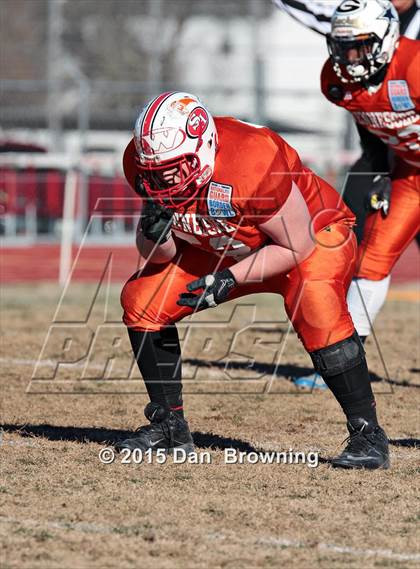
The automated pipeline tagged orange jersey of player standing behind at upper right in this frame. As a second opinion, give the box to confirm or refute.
[321,37,420,167]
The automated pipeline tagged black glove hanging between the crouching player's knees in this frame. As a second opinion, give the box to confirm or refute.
[177,269,237,310]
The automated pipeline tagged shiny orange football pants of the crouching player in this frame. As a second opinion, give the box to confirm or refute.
[121,221,357,352]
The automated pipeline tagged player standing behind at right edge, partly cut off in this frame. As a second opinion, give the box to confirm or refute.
[321,0,420,341]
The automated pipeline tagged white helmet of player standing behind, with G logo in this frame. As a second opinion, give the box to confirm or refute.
[327,0,400,83]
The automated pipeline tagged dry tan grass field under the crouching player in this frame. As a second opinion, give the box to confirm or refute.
[0,284,420,569]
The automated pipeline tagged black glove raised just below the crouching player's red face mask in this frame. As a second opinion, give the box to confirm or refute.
[136,176,173,244]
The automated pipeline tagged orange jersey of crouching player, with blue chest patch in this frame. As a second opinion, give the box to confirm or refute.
[123,117,354,257]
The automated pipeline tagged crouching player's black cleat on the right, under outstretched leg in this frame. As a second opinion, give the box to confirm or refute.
[331,419,389,470]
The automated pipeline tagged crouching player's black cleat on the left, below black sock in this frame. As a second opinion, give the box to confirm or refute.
[115,403,194,454]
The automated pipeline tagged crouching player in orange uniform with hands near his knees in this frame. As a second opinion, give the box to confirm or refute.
[118,92,389,468]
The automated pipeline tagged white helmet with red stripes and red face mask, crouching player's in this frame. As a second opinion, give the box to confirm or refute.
[134,91,217,208]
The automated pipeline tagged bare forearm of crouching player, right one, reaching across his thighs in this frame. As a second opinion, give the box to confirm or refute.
[229,241,315,285]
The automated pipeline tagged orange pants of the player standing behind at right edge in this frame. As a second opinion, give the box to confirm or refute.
[356,160,420,281]
